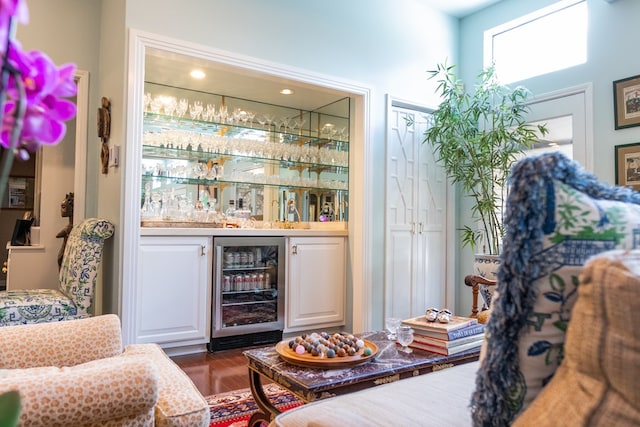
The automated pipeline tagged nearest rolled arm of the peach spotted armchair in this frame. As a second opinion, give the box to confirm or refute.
[0,356,158,427]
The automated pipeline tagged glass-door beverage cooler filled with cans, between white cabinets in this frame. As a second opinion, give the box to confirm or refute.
[209,237,285,351]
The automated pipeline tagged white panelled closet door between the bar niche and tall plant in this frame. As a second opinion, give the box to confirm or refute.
[384,103,448,318]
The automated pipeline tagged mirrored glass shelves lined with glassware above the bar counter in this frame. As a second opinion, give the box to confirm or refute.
[141,83,350,227]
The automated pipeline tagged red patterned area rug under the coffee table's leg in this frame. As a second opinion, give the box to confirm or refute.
[206,383,302,427]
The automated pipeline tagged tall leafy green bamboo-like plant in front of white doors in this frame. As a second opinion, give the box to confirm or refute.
[423,63,547,284]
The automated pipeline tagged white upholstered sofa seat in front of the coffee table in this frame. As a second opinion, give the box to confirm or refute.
[270,362,478,427]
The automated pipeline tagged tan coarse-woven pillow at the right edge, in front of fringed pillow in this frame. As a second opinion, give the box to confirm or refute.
[515,250,640,427]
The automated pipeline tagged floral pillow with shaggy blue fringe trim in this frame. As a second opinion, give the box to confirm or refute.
[471,153,640,426]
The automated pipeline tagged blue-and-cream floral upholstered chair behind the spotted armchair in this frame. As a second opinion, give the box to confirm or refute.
[0,218,114,326]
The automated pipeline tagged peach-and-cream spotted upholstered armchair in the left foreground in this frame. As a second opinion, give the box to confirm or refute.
[0,314,210,427]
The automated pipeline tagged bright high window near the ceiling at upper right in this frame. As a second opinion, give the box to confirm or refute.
[484,0,587,84]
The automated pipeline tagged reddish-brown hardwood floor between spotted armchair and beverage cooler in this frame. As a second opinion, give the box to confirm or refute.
[171,347,268,396]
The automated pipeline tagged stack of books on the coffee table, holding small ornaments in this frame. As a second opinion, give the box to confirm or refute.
[402,316,485,356]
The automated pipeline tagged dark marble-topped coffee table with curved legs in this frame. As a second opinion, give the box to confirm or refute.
[243,332,480,427]
